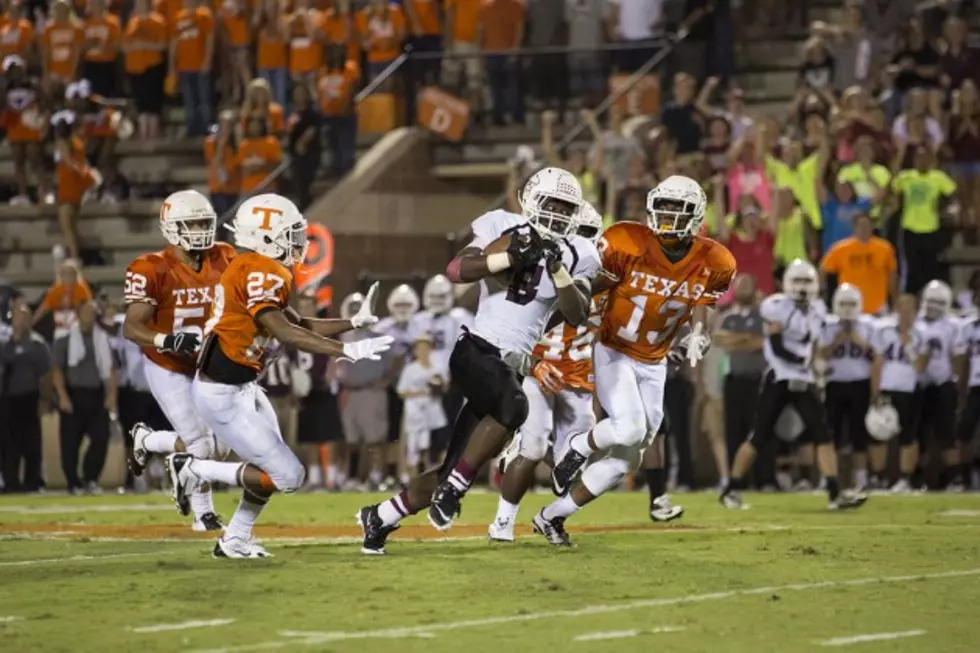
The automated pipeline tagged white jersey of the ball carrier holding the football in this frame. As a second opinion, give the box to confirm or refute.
[469,210,602,355]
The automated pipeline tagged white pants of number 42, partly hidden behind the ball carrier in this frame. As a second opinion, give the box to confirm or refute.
[518,376,595,460]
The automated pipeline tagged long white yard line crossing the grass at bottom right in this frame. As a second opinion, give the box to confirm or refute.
[188,568,980,653]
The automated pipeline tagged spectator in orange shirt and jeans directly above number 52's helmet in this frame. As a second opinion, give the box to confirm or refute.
[170,0,214,136]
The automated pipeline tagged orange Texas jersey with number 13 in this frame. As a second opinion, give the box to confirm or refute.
[599,222,735,363]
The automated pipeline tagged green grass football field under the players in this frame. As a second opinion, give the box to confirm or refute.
[0,493,980,653]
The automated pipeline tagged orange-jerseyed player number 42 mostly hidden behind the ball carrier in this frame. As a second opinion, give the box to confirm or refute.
[487,203,602,542]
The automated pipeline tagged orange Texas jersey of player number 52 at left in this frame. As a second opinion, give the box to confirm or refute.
[125,243,235,376]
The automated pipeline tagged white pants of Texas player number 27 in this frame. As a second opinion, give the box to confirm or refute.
[192,377,306,492]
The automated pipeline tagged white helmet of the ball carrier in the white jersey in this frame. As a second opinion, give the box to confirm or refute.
[521,168,582,240]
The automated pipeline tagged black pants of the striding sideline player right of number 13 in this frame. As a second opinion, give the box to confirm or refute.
[749,371,831,449]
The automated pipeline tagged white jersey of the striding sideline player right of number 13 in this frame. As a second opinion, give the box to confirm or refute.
[759,293,827,383]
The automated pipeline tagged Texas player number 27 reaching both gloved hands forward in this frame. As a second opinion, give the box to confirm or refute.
[166,194,392,558]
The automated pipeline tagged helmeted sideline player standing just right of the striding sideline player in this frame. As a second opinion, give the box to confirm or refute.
[820,283,874,490]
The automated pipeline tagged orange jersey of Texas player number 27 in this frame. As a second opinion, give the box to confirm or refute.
[205,252,293,373]
